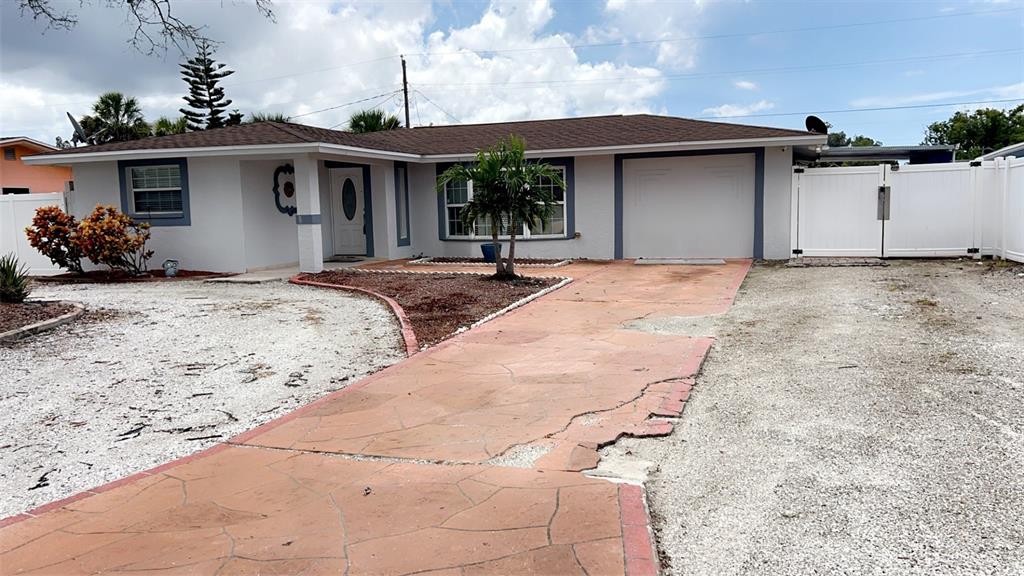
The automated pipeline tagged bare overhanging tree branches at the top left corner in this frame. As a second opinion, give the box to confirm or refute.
[17,0,275,54]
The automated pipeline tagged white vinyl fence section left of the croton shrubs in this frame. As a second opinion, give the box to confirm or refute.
[0,192,66,276]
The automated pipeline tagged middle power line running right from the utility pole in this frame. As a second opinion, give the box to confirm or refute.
[417,48,1024,89]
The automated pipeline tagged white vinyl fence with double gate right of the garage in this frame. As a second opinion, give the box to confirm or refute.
[792,158,1024,261]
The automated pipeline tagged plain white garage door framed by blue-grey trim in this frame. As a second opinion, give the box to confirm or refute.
[623,154,754,258]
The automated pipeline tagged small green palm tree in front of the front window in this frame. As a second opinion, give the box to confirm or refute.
[437,135,565,278]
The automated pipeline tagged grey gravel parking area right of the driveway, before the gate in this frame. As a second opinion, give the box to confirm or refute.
[608,260,1024,575]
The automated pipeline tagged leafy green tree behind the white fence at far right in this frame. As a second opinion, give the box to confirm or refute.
[922,105,1024,160]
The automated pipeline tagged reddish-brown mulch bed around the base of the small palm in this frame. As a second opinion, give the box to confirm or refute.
[300,270,560,345]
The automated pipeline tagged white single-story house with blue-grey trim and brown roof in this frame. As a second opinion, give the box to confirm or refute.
[27,115,825,272]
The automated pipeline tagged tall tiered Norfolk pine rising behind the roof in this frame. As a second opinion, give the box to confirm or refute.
[178,40,242,130]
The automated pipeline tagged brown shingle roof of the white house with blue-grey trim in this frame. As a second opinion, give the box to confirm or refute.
[44,114,815,156]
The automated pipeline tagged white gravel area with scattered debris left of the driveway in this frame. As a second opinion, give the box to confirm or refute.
[0,281,404,517]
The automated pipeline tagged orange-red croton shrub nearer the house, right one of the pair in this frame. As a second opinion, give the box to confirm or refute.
[78,206,153,276]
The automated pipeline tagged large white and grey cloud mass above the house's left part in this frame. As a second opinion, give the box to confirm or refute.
[0,0,666,141]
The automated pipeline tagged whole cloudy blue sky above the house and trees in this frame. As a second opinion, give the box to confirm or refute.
[0,0,1024,145]
